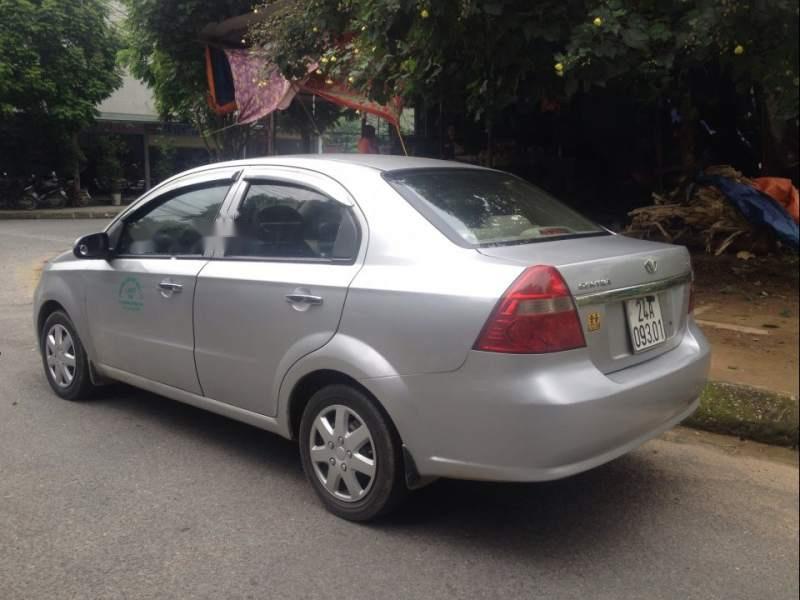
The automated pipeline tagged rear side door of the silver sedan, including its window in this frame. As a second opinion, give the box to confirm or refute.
[195,167,366,416]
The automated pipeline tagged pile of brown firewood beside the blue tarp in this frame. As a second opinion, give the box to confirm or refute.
[624,165,763,256]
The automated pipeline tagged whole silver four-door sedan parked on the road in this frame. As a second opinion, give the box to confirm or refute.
[34,155,709,520]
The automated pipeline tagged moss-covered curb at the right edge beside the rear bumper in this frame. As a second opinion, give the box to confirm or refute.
[683,381,798,448]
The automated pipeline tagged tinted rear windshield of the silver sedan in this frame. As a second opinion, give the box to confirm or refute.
[384,168,607,247]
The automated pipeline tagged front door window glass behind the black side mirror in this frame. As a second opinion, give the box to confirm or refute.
[116,182,230,256]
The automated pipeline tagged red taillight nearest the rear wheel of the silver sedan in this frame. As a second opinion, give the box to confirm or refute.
[474,265,586,354]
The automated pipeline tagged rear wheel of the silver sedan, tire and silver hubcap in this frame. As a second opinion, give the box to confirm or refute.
[299,384,407,521]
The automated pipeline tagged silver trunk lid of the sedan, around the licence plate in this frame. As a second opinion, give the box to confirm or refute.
[478,235,691,373]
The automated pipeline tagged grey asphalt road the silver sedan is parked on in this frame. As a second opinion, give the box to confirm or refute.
[0,221,798,600]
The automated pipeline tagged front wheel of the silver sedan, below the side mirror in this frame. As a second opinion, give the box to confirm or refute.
[39,310,94,400]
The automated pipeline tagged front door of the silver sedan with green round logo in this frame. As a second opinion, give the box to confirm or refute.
[87,170,238,394]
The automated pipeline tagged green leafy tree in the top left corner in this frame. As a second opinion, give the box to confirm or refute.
[0,0,121,187]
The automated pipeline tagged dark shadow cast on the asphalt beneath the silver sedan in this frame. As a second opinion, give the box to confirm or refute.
[87,385,685,555]
